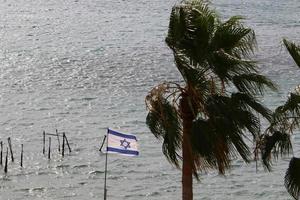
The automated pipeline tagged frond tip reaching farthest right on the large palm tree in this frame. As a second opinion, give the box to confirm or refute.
[232,73,277,95]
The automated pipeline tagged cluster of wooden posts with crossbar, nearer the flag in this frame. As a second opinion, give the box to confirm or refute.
[43,129,72,159]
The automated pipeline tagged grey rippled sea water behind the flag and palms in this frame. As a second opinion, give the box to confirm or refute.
[0,0,300,200]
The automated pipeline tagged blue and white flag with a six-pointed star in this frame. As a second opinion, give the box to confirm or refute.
[107,129,139,156]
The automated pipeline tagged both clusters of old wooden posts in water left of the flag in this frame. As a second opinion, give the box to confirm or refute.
[0,130,72,173]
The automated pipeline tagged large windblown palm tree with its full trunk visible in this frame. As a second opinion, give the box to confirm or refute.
[146,0,275,200]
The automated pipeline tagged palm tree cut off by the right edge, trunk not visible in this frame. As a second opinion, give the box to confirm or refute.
[258,39,300,199]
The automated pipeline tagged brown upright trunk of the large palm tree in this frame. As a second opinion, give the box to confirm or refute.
[180,95,193,200]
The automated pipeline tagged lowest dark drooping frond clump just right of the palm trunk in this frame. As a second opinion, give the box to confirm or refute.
[191,113,251,174]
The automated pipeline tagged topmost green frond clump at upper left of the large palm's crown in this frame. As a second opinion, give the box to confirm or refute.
[166,0,218,67]
